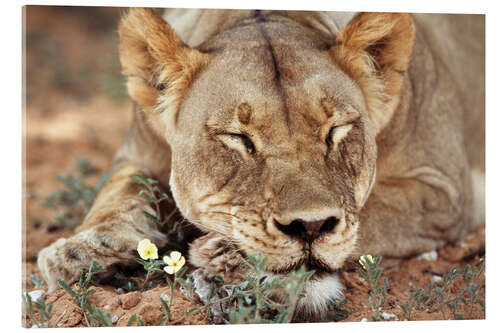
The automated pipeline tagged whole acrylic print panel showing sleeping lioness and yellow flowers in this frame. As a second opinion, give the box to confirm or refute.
[22,6,485,327]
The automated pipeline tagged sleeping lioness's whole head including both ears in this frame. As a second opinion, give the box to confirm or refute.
[119,9,414,312]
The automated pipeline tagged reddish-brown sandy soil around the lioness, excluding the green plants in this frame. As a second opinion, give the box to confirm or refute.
[22,7,485,327]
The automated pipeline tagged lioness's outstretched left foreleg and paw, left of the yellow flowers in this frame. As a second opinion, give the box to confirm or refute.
[38,162,167,292]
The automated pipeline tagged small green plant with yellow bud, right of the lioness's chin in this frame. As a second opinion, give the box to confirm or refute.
[358,255,388,321]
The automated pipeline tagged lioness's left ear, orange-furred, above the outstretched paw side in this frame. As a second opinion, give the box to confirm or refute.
[118,8,208,110]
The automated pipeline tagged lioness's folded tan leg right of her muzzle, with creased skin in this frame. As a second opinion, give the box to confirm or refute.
[351,168,480,260]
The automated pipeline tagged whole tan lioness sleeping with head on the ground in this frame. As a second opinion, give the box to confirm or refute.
[38,8,484,315]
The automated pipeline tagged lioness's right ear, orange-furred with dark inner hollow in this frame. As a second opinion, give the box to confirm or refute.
[331,13,415,132]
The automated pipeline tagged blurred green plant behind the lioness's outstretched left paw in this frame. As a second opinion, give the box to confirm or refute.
[43,158,109,230]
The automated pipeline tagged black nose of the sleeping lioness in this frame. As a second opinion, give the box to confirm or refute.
[275,216,339,242]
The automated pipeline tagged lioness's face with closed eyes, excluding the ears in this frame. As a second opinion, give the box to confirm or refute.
[166,17,376,273]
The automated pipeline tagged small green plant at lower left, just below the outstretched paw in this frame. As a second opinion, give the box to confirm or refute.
[57,261,112,327]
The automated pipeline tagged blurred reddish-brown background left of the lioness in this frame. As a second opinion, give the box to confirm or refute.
[23,6,132,288]
